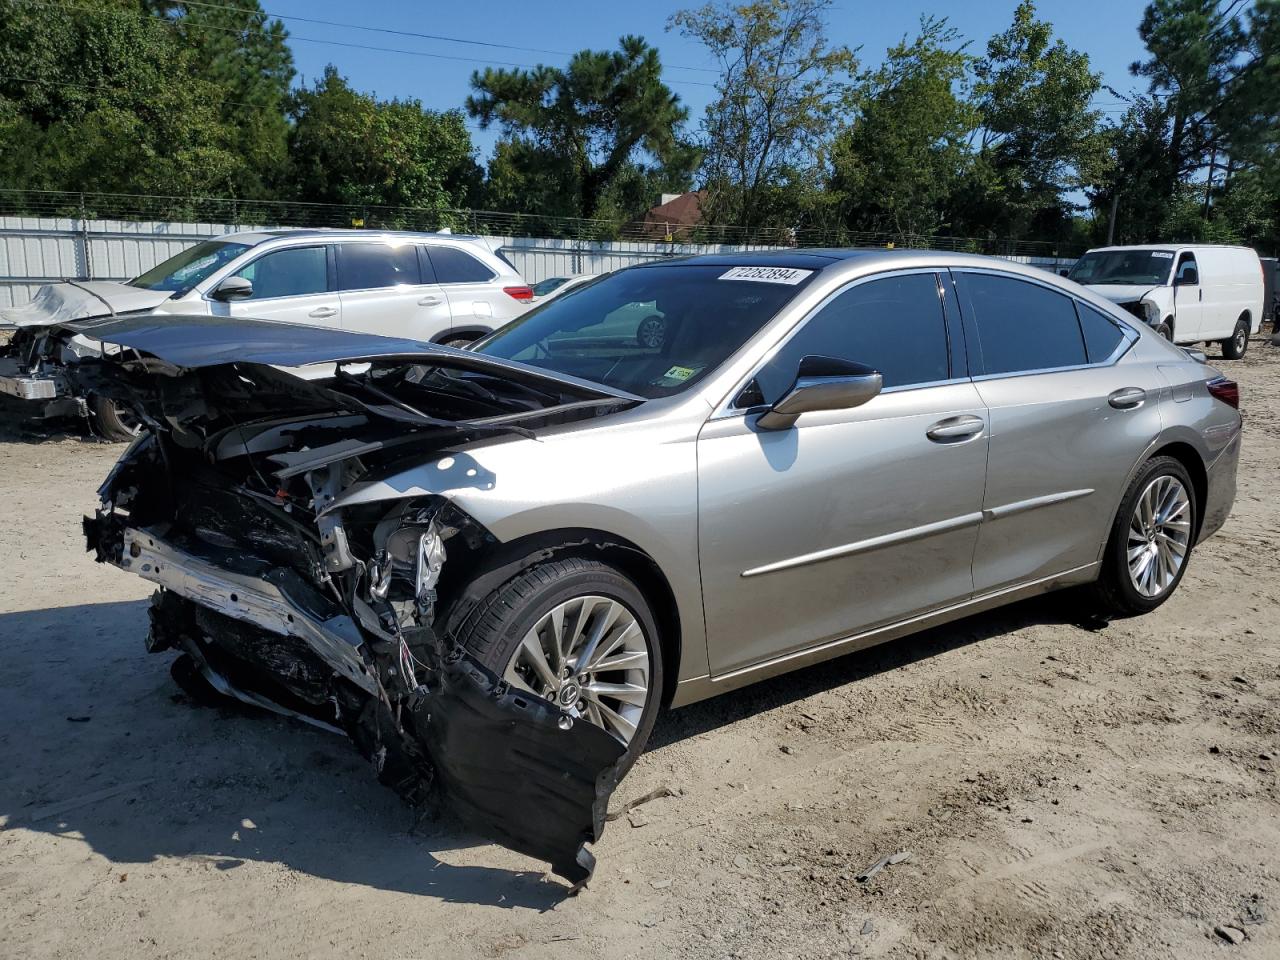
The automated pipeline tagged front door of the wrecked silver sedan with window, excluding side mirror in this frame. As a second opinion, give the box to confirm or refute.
[698,271,987,677]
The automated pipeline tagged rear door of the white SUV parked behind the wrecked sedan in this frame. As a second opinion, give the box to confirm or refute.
[335,241,451,340]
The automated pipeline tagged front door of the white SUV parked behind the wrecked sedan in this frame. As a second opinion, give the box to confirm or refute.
[220,243,342,326]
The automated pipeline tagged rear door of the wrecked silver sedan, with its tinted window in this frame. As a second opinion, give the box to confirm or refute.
[955,270,1164,594]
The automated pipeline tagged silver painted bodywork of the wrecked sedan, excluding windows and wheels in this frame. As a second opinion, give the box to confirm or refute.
[330,252,1240,705]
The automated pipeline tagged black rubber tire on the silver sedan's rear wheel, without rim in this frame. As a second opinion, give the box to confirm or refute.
[1093,457,1197,617]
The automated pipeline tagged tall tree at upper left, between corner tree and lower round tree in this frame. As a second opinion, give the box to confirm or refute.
[143,0,294,198]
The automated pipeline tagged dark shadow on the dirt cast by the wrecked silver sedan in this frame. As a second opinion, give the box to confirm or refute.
[0,598,1100,910]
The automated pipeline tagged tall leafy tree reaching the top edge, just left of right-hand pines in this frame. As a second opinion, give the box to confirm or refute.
[965,0,1105,238]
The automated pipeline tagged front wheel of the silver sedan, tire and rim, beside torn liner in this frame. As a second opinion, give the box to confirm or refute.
[458,557,663,780]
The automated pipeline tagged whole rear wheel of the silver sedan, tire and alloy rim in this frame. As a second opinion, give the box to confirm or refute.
[1094,457,1196,617]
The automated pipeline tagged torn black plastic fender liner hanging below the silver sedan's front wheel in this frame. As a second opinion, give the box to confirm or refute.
[413,648,625,892]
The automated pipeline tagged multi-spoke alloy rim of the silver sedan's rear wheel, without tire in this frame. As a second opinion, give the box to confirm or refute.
[1126,474,1192,599]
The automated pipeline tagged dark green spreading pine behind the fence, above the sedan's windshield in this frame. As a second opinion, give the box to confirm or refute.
[466,36,698,216]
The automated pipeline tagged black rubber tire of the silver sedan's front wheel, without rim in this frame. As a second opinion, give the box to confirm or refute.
[457,557,663,781]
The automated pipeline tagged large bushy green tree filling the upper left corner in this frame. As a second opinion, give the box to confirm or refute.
[0,0,246,196]
